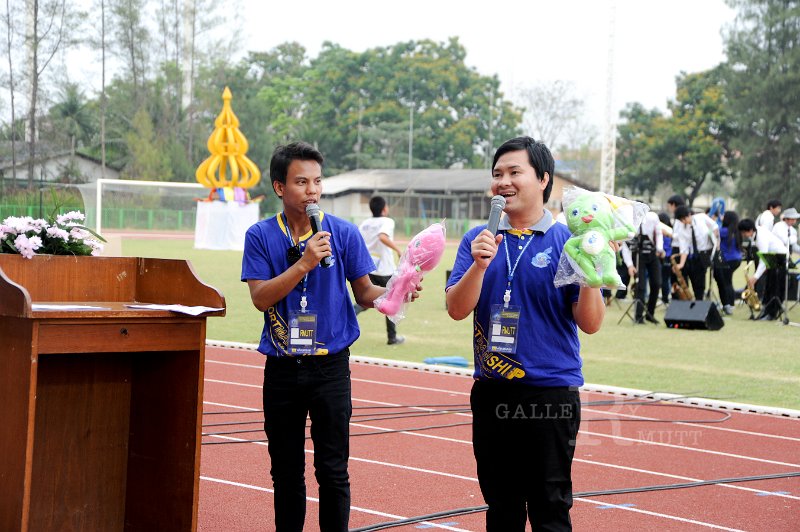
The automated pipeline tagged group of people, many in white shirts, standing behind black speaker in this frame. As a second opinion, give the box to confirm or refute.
[616,195,800,323]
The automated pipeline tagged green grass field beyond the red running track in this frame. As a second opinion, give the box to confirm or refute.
[122,239,800,409]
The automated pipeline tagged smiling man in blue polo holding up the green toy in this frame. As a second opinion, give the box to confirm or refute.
[447,137,605,532]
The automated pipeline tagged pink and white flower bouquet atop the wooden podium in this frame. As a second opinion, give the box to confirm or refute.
[0,211,106,259]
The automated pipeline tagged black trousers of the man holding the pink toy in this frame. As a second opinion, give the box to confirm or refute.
[264,350,353,532]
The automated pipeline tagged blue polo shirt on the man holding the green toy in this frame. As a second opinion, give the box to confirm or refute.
[447,209,583,387]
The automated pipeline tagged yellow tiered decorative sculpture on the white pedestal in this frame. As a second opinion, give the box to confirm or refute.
[195,87,261,196]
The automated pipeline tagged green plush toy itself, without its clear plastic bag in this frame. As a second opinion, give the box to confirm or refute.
[564,192,635,288]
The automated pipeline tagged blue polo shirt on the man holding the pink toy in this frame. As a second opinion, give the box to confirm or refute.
[242,213,375,356]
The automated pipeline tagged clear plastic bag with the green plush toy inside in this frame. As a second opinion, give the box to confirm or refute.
[554,187,650,288]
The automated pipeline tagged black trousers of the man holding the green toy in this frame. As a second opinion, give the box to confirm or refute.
[470,381,581,532]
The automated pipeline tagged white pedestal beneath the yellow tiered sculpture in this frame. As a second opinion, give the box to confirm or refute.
[194,201,259,251]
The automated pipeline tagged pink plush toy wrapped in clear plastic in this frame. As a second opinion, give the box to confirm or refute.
[375,223,445,323]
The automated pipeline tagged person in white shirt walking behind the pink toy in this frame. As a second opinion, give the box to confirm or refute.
[355,196,406,345]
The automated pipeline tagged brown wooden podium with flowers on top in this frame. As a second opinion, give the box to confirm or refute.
[0,254,225,531]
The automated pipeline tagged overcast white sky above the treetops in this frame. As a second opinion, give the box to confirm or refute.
[240,0,735,132]
